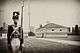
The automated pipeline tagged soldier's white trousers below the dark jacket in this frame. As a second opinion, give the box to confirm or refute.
[11,38,20,53]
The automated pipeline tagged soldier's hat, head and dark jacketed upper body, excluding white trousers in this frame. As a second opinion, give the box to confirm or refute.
[7,12,23,50]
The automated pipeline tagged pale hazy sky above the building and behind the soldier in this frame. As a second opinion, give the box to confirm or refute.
[0,0,80,31]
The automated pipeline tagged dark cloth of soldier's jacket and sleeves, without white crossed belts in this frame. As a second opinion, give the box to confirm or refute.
[7,25,23,44]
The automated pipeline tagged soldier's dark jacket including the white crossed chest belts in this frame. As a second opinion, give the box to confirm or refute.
[7,25,23,45]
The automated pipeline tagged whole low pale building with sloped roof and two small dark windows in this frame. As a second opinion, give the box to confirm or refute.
[36,23,70,37]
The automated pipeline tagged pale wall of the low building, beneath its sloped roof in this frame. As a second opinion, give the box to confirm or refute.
[36,28,69,37]
